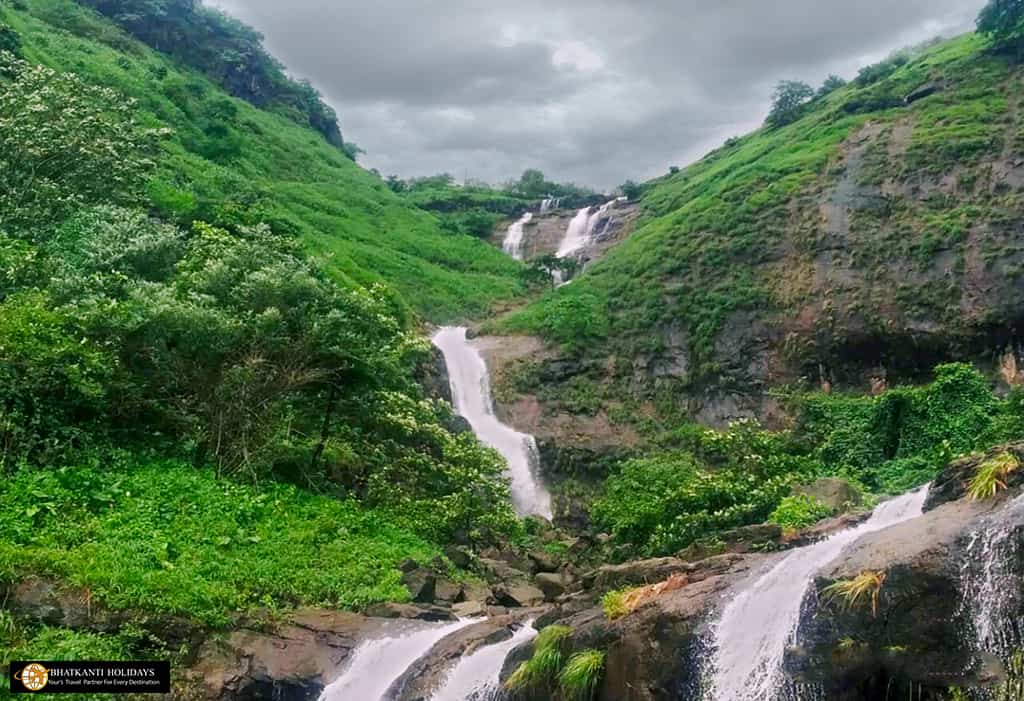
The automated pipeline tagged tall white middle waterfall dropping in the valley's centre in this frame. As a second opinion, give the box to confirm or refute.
[433,326,552,519]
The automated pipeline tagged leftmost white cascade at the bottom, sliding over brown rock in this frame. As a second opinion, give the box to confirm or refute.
[319,619,476,701]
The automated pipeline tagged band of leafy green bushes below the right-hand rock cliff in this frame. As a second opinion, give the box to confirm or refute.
[592,364,1024,556]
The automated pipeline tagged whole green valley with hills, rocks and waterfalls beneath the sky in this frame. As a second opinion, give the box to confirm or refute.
[0,0,1024,701]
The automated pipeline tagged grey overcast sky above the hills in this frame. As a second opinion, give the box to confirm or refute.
[213,0,984,188]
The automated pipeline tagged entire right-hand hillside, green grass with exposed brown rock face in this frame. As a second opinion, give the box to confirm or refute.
[499,35,1024,408]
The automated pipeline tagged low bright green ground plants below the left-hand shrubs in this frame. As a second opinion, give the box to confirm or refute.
[0,455,439,624]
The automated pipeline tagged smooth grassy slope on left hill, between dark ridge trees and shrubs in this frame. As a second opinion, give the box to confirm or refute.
[3,0,518,321]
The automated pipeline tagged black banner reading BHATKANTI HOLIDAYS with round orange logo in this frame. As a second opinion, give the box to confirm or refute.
[10,661,171,694]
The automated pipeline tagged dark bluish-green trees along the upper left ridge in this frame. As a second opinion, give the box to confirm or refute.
[78,0,359,154]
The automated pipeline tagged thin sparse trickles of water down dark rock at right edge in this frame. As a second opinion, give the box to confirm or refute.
[961,494,1024,662]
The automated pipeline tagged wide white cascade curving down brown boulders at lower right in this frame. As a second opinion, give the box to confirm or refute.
[708,487,928,701]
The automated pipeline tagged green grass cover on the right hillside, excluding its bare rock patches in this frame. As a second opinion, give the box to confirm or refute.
[500,35,1024,374]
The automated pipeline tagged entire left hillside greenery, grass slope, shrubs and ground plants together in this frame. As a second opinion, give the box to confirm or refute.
[0,0,521,638]
